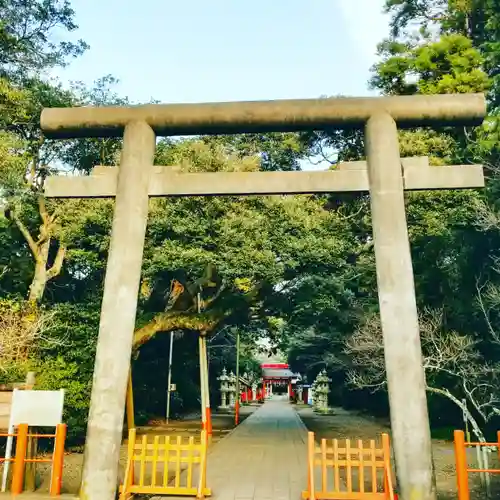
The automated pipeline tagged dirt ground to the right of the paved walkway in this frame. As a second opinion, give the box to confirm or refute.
[296,405,500,500]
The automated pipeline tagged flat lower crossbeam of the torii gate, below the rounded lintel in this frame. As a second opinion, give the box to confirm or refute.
[45,158,484,198]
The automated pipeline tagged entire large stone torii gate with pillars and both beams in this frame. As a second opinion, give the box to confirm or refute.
[41,94,486,500]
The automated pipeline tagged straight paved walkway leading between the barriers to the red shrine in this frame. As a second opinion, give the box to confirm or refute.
[207,400,307,500]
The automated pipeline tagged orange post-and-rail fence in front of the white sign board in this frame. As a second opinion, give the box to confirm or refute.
[0,424,66,496]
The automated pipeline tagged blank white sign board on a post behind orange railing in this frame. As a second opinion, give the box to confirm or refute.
[2,389,64,492]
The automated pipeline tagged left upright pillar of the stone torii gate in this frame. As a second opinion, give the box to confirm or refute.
[80,122,156,499]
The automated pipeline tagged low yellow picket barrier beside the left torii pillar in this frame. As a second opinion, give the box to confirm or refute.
[120,429,211,500]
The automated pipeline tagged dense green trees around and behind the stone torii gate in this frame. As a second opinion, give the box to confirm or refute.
[0,0,500,446]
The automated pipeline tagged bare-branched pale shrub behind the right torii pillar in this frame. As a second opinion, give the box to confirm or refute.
[344,308,500,438]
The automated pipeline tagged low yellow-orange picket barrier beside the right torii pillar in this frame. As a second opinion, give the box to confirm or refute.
[302,432,397,500]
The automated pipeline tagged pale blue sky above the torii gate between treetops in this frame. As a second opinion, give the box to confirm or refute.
[55,0,388,103]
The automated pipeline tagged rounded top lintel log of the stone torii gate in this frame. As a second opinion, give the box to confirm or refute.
[40,94,486,139]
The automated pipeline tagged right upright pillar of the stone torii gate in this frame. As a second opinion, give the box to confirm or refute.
[365,112,436,500]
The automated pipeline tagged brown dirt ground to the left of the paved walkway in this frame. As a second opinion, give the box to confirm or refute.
[23,406,257,494]
